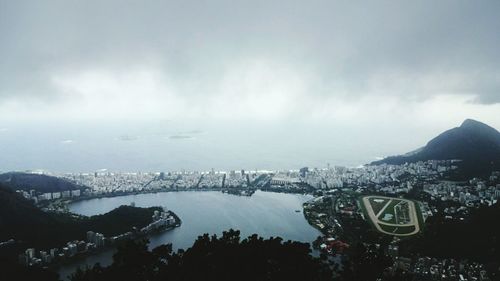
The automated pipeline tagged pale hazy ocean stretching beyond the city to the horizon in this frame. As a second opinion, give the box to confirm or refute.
[0,117,414,172]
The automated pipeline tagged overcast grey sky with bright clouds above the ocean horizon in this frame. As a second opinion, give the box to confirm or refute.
[0,0,500,171]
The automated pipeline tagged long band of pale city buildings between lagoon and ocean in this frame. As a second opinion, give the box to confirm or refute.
[12,160,500,214]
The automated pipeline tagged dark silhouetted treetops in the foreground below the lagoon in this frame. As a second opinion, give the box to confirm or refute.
[71,230,332,281]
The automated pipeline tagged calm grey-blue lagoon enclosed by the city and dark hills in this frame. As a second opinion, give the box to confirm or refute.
[59,191,320,278]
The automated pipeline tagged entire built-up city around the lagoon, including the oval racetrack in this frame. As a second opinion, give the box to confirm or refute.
[6,160,500,280]
